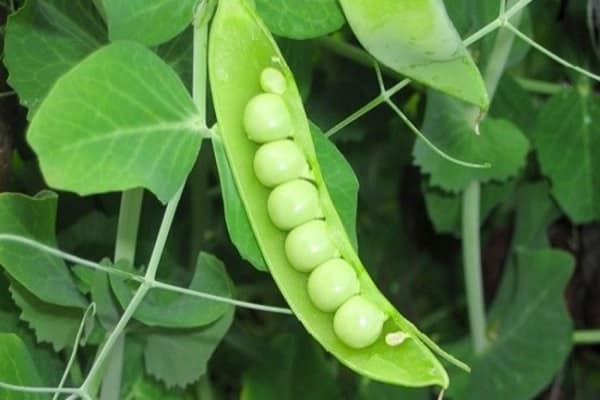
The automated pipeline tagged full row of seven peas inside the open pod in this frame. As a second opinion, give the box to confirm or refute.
[243,67,387,349]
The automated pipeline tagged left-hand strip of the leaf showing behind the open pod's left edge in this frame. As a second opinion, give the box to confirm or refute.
[212,138,267,271]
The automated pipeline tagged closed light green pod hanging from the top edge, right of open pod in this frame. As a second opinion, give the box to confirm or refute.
[340,0,489,110]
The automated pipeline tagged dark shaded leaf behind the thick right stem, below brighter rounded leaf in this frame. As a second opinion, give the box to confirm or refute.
[423,180,515,237]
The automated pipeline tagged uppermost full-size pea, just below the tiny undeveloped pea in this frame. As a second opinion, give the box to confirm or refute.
[244,93,294,143]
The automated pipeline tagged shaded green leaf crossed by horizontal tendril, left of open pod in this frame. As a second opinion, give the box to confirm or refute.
[110,253,232,328]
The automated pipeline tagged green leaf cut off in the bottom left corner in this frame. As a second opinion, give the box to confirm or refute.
[0,333,50,400]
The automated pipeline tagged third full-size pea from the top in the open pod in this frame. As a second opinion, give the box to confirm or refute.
[267,179,323,231]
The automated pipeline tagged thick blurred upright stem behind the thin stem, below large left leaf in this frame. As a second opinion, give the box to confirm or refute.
[100,188,144,400]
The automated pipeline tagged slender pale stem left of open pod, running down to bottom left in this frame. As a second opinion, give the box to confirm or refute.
[81,0,215,397]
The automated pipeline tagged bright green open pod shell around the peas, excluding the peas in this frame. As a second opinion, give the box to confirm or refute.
[209,0,467,387]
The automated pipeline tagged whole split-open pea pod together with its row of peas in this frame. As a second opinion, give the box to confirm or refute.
[209,0,460,388]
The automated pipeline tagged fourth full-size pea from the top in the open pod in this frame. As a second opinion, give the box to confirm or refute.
[285,220,339,272]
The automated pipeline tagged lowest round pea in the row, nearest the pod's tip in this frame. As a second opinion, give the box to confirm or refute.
[333,295,386,349]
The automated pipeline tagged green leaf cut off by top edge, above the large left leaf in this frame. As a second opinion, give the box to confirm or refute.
[102,0,199,46]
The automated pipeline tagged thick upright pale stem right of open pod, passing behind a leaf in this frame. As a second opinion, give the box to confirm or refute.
[462,0,528,353]
